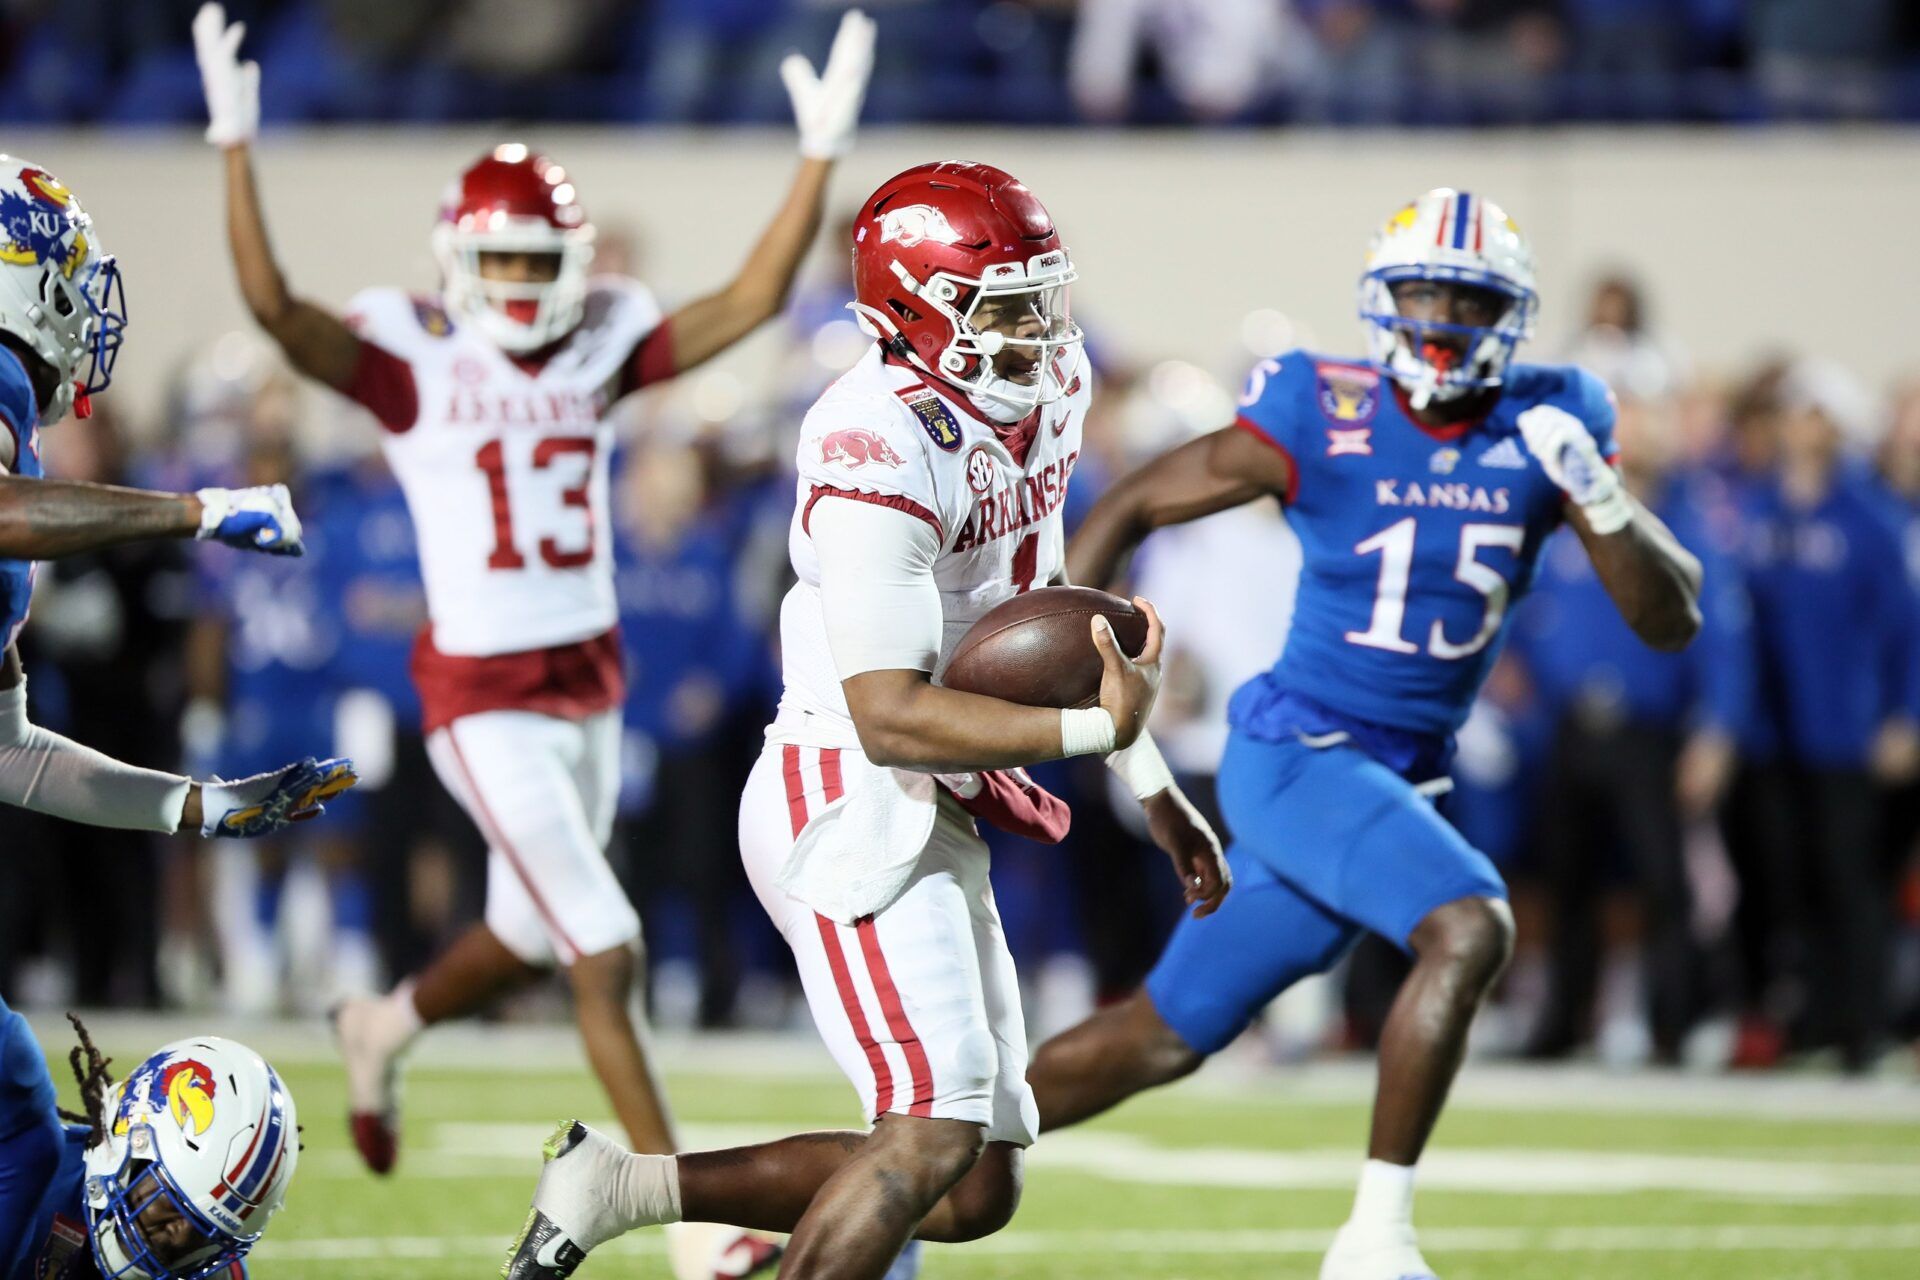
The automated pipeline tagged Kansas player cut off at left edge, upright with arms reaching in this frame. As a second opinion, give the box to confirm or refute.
[0,155,353,837]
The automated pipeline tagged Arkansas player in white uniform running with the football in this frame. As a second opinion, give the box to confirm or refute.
[505,163,1227,1280]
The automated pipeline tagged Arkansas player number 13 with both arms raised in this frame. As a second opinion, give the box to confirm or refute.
[194,4,874,1274]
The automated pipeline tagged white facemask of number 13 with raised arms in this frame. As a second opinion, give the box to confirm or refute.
[434,215,593,355]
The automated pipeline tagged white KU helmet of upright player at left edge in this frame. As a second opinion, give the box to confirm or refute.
[0,154,127,426]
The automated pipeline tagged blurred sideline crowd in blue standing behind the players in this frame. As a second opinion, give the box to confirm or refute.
[0,217,1920,1071]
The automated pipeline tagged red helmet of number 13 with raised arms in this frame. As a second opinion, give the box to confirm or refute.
[434,142,593,351]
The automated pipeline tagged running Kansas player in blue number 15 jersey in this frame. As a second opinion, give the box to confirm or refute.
[1027,190,1699,1280]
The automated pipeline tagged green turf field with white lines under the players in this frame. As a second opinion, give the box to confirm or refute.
[36,1021,1920,1280]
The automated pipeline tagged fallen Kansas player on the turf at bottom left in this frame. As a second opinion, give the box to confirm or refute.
[0,1000,300,1280]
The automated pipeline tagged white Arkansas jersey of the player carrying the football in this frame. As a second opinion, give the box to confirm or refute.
[768,344,1092,748]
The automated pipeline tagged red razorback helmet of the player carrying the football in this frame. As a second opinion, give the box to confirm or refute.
[852,161,1081,413]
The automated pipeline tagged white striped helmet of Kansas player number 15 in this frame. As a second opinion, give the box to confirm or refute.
[1359,186,1540,407]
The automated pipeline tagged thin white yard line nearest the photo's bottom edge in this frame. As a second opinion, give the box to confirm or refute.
[253,1222,1920,1263]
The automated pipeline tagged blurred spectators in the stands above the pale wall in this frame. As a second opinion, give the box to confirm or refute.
[11,0,1920,125]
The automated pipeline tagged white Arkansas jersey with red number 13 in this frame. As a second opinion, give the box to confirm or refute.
[349,276,660,656]
